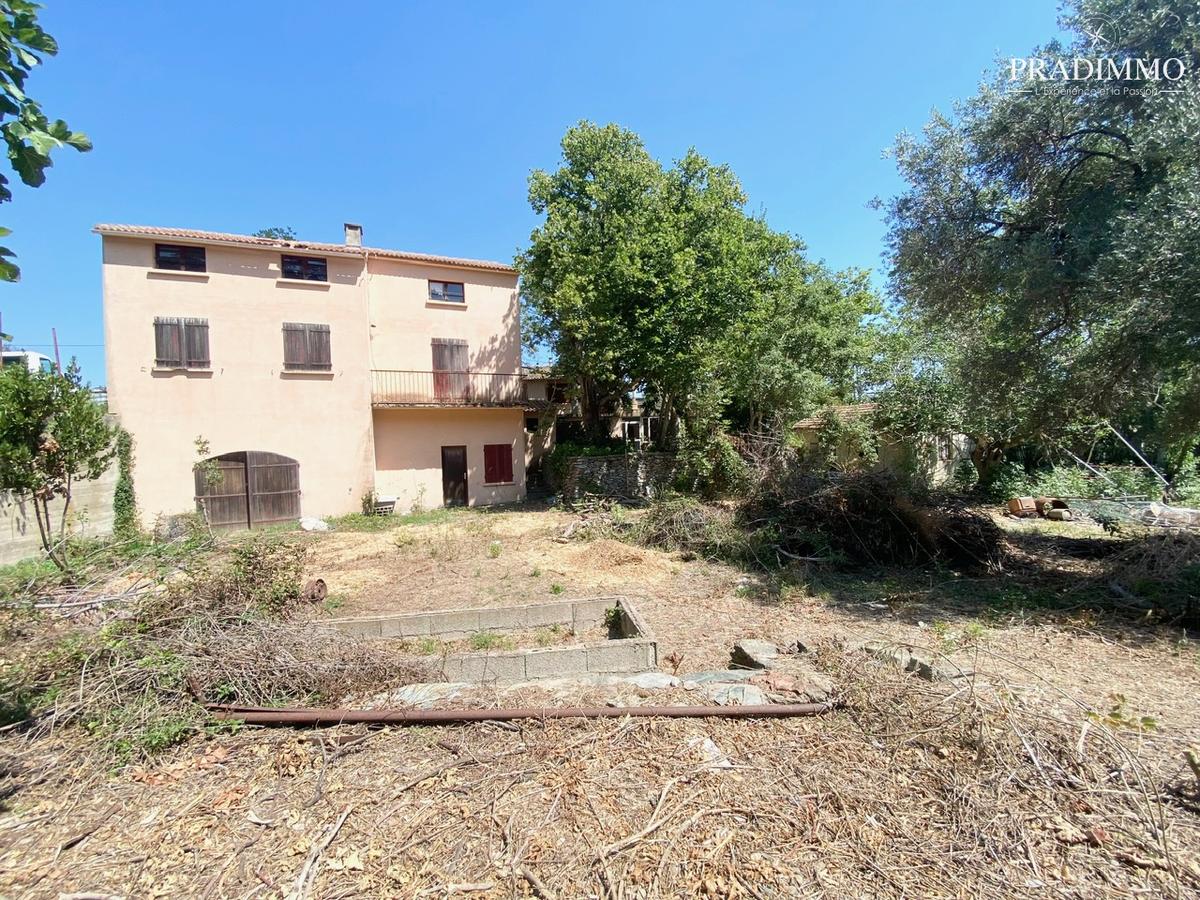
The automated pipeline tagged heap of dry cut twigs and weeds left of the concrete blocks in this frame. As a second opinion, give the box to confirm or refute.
[0,538,424,762]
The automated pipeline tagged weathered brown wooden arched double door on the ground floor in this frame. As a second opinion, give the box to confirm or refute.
[196,450,300,528]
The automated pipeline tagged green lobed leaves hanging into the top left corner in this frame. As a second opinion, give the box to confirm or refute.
[0,0,91,281]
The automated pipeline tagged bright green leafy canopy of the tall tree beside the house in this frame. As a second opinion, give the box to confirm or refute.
[517,122,875,444]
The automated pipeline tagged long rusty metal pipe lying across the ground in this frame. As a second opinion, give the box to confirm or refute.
[208,703,834,726]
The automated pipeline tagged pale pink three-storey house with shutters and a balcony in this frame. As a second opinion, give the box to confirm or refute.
[104,224,526,527]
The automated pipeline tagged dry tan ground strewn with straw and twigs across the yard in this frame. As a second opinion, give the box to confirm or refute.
[0,510,1200,898]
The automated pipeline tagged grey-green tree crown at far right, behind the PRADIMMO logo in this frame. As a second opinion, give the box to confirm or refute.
[887,0,1200,478]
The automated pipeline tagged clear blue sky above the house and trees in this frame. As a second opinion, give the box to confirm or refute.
[0,0,1057,384]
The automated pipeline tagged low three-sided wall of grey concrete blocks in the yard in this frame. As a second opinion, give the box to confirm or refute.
[322,596,658,682]
